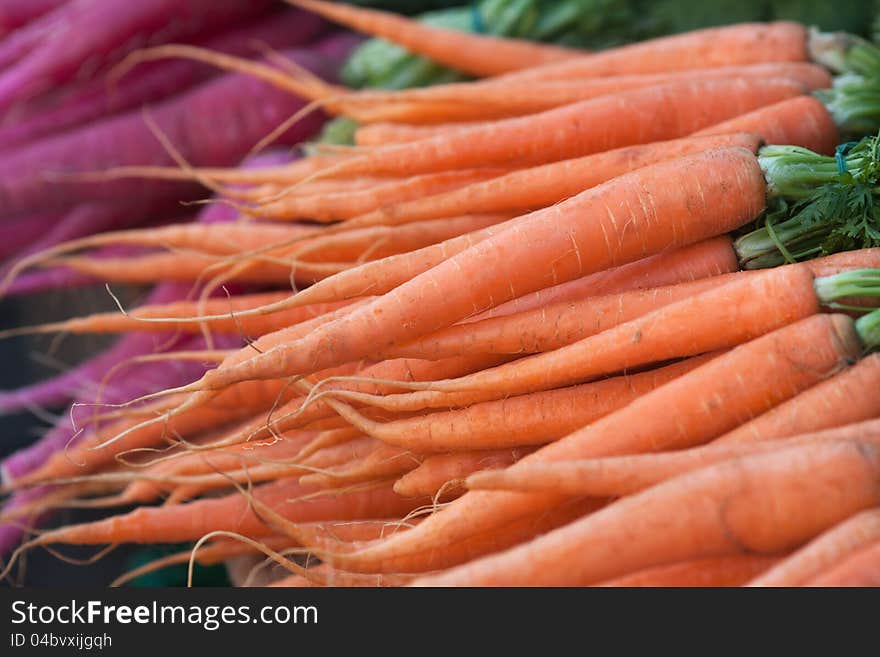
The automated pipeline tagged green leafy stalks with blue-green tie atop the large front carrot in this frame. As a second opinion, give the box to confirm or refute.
[734,137,880,269]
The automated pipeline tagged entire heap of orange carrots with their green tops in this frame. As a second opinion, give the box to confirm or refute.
[0,0,880,586]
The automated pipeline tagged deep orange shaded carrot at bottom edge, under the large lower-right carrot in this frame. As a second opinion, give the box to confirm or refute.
[598,554,782,587]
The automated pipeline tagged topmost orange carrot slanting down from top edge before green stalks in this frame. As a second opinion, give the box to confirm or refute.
[287,0,580,76]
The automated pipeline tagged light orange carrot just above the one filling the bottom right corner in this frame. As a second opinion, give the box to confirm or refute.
[749,509,880,586]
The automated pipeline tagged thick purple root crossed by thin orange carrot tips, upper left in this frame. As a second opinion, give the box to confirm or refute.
[0,42,354,216]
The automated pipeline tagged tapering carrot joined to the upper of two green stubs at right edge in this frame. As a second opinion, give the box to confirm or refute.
[326,265,820,412]
